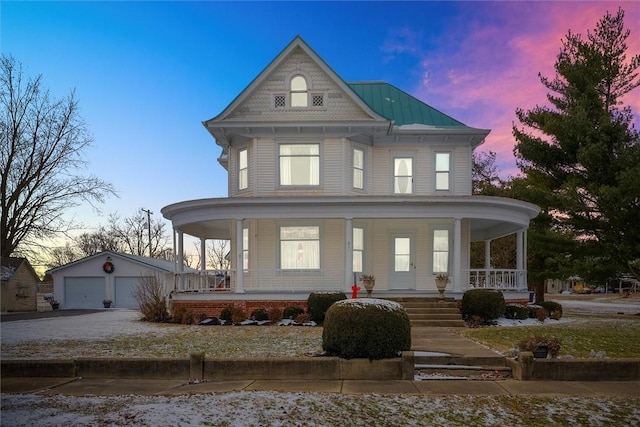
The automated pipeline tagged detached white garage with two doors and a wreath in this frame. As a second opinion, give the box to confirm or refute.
[47,251,197,308]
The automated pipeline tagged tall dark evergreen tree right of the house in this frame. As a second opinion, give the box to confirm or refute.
[513,9,640,278]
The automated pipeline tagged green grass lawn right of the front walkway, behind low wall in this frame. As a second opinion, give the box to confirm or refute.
[462,315,640,358]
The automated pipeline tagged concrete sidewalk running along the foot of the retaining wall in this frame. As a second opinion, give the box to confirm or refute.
[1,378,640,398]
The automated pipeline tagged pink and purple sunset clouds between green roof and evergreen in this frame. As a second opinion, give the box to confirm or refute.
[412,2,640,175]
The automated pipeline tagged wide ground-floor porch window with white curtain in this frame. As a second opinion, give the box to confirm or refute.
[280,226,320,270]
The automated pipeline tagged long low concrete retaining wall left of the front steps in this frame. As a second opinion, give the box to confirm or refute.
[1,352,414,381]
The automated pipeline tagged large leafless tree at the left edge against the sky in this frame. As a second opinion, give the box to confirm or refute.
[0,55,115,256]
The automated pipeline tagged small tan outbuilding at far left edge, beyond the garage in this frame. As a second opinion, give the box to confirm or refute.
[0,257,40,312]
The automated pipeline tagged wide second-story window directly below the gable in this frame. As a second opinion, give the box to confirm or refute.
[279,144,320,186]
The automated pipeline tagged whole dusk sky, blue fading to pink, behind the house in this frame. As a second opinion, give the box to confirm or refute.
[0,1,640,244]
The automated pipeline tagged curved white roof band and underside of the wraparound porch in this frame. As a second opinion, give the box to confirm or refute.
[162,196,539,241]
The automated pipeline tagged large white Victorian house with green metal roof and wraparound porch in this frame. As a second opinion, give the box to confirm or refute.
[162,37,539,314]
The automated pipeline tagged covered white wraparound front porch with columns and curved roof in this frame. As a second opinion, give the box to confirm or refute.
[163,196,537,299]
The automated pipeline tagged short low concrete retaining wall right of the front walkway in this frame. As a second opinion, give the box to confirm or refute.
[507,352,640,381]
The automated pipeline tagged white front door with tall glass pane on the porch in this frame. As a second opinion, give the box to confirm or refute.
[389,233,416,290]
